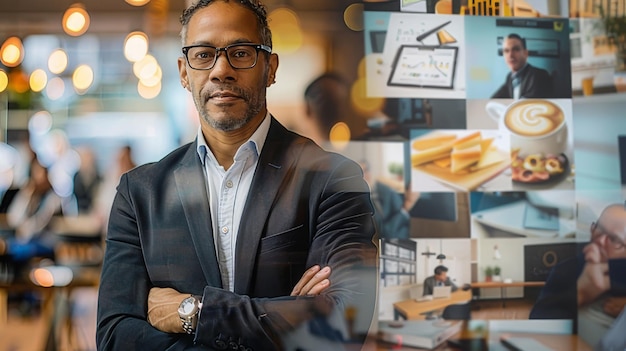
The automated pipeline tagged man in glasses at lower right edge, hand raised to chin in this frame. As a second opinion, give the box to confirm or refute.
[530,204,626,319]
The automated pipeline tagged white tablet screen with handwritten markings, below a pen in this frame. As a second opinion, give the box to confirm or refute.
[387,45,458,89]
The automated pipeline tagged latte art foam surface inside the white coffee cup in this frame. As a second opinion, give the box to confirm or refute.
[505,100,563,136]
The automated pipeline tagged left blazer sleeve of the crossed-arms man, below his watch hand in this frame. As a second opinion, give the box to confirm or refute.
[96,175,194,350]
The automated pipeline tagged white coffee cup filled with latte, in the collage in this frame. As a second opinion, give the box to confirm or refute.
[485,99,567,156]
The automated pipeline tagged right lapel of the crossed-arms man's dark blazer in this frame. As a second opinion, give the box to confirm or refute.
[235,117,294,294]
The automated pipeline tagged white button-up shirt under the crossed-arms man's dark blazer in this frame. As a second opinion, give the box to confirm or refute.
[197,112,271,291]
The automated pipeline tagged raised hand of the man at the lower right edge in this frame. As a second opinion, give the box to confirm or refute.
[577,243,611,306]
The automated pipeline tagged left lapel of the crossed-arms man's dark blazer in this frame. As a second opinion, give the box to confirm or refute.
[174,141,222,288]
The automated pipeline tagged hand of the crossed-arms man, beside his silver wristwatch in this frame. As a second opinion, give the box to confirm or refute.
[148,287,189,333]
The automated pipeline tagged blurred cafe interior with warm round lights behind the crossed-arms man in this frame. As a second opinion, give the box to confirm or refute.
[0,0,377,350]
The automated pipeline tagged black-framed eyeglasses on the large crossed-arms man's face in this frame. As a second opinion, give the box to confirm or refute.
[183,43,272,70]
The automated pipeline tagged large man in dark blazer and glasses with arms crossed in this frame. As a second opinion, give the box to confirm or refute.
[96,0,378,350]
